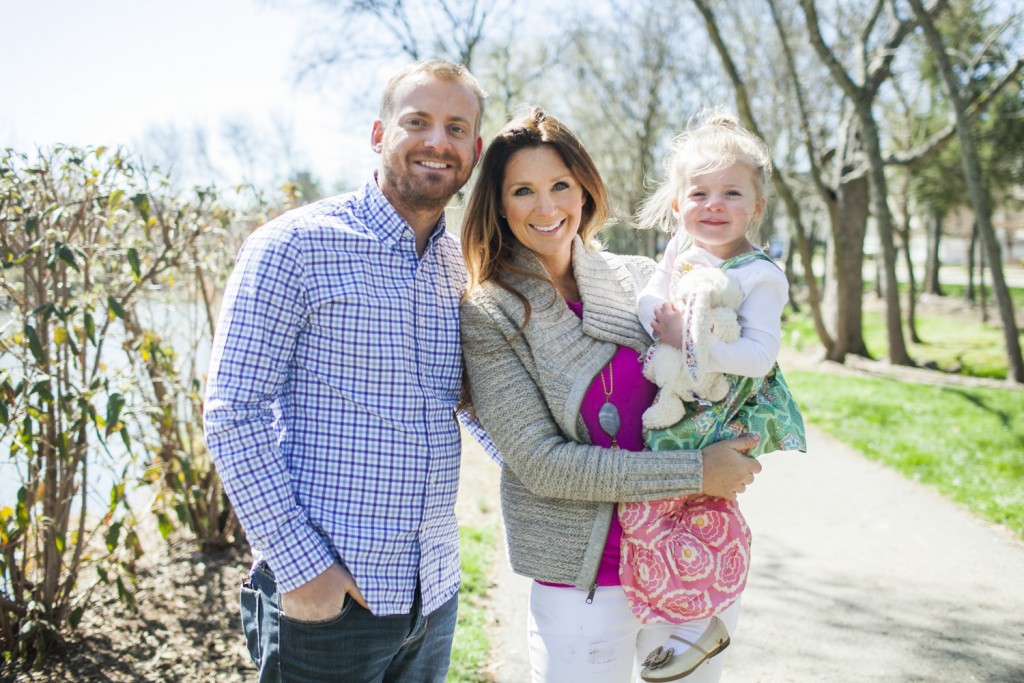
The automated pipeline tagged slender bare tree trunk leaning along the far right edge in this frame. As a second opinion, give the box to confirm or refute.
[908,0,1024,383]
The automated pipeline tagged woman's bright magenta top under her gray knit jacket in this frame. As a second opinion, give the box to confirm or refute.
[548,301,657,586]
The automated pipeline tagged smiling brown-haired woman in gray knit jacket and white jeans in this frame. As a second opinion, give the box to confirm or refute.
[462,102,761,683]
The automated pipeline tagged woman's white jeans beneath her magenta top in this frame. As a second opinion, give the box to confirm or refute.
[528,582,739,683]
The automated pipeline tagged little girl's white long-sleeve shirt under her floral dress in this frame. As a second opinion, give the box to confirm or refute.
[637,231,790,377]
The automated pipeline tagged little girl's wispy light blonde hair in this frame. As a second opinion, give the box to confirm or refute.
[636,110,772,232]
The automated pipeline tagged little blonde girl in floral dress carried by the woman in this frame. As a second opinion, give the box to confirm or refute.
[618,113,806,681]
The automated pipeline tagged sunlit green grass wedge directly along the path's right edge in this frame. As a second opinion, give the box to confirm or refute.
[785,371,1024,539]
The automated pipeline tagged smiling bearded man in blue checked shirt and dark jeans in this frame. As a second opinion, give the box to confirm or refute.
[205,60,485,681]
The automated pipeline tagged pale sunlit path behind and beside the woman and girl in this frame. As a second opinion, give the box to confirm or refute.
[467,405,1024,683]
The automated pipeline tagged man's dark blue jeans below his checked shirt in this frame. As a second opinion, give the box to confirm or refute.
[241,563,459,683]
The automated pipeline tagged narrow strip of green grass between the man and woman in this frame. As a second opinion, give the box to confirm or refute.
[446,526,499,683]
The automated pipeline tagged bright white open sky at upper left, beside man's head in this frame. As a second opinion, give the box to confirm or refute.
[0,0,377,185]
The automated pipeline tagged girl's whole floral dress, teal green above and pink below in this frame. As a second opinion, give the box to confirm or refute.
[618,252,807,624]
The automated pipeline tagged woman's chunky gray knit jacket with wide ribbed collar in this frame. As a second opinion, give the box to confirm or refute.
[462,238,702,589]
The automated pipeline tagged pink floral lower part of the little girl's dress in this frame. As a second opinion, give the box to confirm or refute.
[618,496,751,624]
